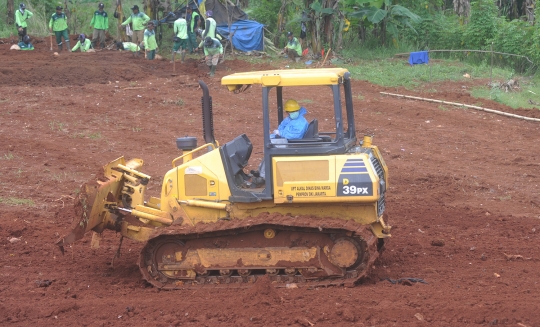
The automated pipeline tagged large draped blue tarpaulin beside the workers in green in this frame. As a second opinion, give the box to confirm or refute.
[217,20,264,52]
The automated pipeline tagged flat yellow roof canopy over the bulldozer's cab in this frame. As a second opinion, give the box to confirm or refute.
[221,68,348,91]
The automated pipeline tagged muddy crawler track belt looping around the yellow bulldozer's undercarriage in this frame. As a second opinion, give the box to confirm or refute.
[138,214,383,290]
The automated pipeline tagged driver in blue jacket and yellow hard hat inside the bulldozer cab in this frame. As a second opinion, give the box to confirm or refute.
[270,100,309,140]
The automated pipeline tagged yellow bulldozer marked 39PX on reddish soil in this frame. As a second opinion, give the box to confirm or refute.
[57,68,390,289]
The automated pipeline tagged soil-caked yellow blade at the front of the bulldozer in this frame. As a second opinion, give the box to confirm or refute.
[56,157,130,253]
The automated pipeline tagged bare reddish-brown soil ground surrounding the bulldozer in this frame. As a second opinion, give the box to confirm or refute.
[0,39,540,326]
